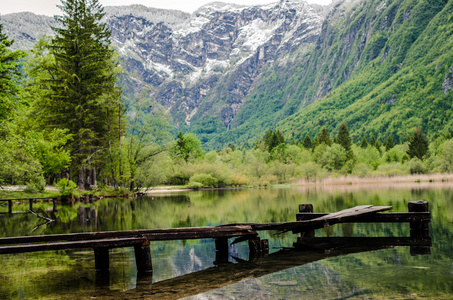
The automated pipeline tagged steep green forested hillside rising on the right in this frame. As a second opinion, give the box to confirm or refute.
[237,1,453,146]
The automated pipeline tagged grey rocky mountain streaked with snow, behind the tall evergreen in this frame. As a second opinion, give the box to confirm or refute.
[1,0,327,139]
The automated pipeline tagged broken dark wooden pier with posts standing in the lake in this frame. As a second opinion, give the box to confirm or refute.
[0,201,431,273]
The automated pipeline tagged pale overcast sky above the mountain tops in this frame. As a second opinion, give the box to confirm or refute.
[0,0,331,16]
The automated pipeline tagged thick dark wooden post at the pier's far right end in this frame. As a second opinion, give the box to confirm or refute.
[407,201,431,256]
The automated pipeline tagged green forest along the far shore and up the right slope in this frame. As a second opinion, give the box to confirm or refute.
[0,0,453,192]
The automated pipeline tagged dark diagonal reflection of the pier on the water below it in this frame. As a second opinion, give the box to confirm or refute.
[96,237,431,299]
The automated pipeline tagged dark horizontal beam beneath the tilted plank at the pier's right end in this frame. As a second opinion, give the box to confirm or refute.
[296,212,431,223]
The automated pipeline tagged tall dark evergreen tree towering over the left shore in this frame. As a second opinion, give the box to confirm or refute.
[46,0,123,189]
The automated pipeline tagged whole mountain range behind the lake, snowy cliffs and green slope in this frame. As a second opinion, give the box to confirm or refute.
[1,0,453,148]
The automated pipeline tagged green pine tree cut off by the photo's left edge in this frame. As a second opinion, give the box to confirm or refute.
[0,23,25,125]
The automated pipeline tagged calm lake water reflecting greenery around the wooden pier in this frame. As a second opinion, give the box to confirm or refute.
[0,183,453,299]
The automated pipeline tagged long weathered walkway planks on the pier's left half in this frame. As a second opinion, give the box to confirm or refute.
[0,226,257,245]
